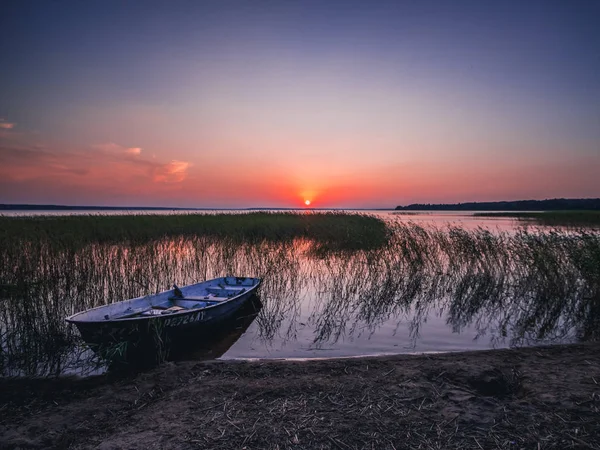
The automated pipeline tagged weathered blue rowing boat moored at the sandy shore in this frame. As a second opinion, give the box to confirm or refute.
[66,277,261,356]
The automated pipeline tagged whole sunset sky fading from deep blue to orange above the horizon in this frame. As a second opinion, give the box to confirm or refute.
[0,0,600,208]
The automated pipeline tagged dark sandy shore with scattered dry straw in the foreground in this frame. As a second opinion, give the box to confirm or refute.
[0,344,600,449]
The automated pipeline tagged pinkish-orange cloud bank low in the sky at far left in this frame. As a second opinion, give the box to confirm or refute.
[0,128,192,201]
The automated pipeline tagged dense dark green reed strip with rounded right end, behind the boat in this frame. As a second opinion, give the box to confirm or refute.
[0,212,388,249]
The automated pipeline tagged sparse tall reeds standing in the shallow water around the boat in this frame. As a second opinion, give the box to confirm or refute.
[0,214,600,376]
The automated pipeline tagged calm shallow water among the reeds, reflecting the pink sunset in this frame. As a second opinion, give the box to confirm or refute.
[0,211,600,375]
